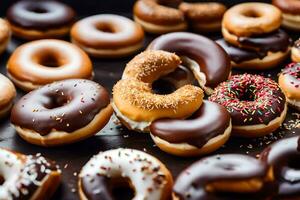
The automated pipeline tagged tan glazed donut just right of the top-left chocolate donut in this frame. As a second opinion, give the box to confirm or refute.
[71,14,144,58]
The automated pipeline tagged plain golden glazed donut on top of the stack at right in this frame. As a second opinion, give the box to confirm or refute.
[222,2,281,40]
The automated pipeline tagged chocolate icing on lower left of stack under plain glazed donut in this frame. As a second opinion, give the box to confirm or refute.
[216,39,268,63]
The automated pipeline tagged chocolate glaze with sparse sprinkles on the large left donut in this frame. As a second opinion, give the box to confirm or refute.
[11,79,110,135]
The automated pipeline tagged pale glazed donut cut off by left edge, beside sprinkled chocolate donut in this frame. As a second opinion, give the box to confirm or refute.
[0,74,16,118]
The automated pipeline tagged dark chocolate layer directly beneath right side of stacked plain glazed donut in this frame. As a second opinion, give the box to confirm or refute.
[238,29,292,52]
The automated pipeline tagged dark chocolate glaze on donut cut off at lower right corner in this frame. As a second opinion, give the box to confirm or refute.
[260,136,300,196]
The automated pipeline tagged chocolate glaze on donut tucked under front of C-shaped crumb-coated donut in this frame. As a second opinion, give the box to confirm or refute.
[150,101,230,148]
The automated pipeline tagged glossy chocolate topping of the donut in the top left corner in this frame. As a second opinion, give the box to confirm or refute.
[6,0,75,30]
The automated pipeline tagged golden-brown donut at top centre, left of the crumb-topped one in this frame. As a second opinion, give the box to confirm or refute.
[133,0,187,34]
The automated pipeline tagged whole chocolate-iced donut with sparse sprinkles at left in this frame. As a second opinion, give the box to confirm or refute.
[10,79,113,146]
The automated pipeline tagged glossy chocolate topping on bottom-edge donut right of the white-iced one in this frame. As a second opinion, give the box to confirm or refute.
[173,154,268,200]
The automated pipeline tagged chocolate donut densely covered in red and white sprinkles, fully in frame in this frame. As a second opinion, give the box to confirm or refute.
[209,73,287,137]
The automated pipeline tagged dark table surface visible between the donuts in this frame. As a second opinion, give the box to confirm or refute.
[0,0,300,200]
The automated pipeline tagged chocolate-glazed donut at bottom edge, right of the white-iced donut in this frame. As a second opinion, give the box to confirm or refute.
[173,154,268,200]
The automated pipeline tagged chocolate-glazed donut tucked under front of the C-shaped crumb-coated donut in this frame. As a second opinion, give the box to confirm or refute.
[150,101,231,156]
